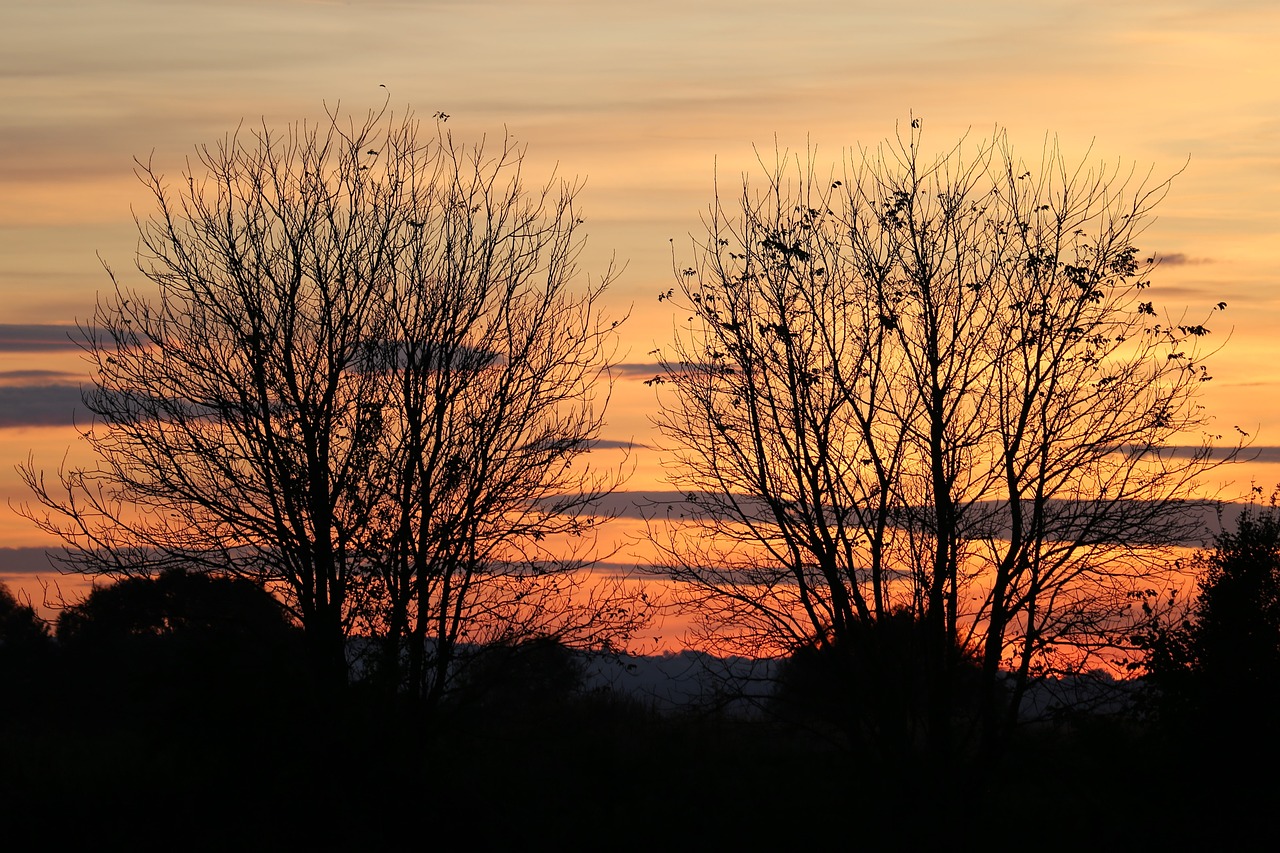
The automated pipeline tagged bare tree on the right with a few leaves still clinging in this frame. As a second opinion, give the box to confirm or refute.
[654,122,1238,754]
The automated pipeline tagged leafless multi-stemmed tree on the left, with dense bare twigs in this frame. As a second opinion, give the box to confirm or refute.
[20,109,632,684]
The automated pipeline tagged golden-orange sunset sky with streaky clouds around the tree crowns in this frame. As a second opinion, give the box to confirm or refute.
[0,0,1280,617]
